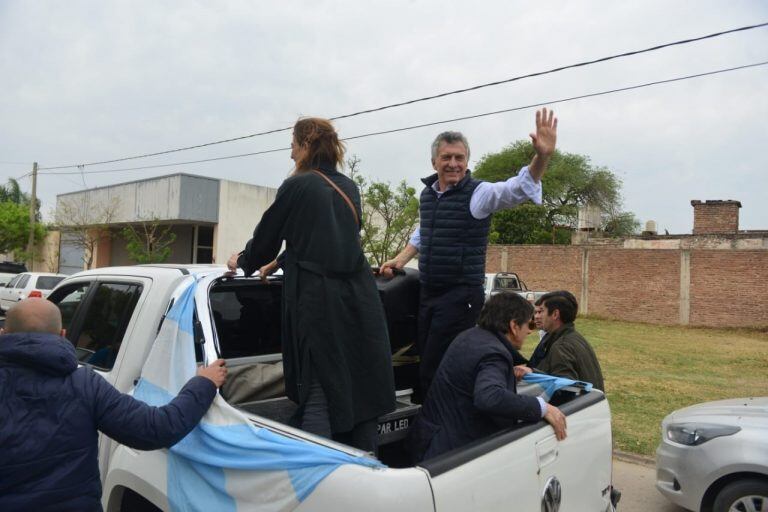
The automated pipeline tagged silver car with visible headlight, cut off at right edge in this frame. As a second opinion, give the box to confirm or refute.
[656,397,768,512]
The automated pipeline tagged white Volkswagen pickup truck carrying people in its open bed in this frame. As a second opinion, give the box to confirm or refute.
[43,265,615,512]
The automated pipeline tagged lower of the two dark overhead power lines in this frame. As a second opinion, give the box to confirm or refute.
[38,61,768,176]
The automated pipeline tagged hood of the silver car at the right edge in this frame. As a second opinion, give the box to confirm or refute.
[664,397,768,428]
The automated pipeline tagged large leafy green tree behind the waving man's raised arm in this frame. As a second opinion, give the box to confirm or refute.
[474,140,640,244]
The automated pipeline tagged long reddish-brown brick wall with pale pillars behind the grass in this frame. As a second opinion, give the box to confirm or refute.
[486,245,768,327]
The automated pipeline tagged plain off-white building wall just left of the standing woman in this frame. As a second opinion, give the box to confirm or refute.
[213,180,277,264]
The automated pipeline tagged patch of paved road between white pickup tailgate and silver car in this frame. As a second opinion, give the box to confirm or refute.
[613,458,687,512]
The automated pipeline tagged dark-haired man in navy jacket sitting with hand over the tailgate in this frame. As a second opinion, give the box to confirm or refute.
[413,293,566,460]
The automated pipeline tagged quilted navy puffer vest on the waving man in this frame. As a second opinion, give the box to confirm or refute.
[419,171,491,288]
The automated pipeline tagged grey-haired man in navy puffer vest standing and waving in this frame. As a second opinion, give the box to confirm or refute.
[381,108,557,399]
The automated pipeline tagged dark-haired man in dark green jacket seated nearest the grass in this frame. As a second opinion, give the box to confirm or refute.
[529,291,605,391]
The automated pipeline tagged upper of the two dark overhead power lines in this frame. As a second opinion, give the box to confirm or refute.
[40,22,768,171]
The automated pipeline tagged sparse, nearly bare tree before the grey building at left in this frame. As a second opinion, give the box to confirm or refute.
[53,198,120,269]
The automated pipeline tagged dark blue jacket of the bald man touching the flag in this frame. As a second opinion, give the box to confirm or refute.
[0,333,216,512]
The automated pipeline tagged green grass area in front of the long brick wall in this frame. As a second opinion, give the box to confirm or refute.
[522,318,768,455]
